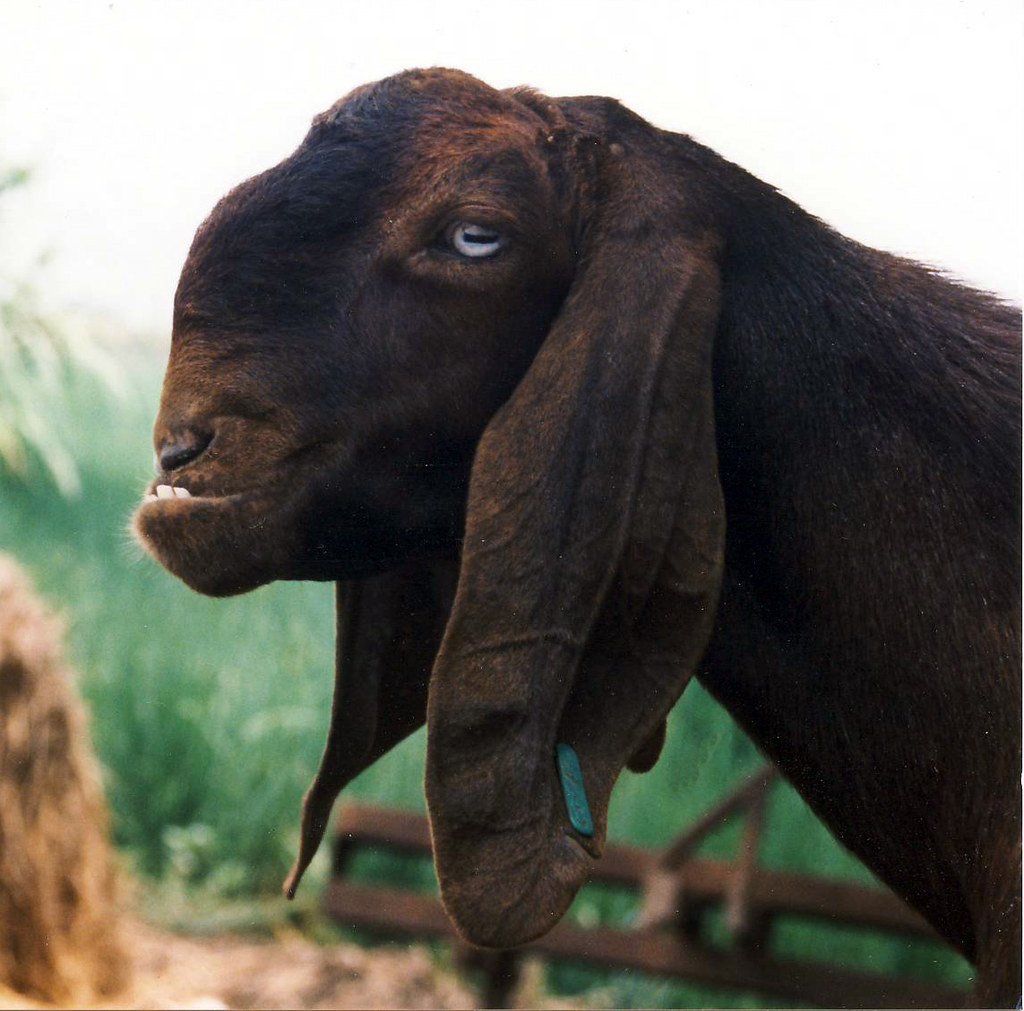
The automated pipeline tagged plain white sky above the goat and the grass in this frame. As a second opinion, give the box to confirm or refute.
[0,0,1024,334]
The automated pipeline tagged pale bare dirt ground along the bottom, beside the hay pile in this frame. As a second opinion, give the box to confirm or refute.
[0,921,575,1011]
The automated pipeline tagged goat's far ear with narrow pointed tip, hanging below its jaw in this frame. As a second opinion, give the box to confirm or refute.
[285,563,456,898]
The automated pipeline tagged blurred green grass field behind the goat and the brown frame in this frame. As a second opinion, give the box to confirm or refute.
[0,355,969,1007]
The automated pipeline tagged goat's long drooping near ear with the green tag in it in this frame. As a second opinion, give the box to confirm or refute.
[427,128,724,946]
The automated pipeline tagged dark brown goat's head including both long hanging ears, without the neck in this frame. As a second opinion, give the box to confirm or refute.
[136,71,724,945]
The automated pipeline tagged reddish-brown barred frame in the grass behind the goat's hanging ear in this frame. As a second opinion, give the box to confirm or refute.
[325,770,966,1008]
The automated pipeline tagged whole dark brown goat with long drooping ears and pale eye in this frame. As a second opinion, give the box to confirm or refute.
[136,71,1021,1005]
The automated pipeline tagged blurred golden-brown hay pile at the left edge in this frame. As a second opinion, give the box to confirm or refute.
[0,555,126,1003]
